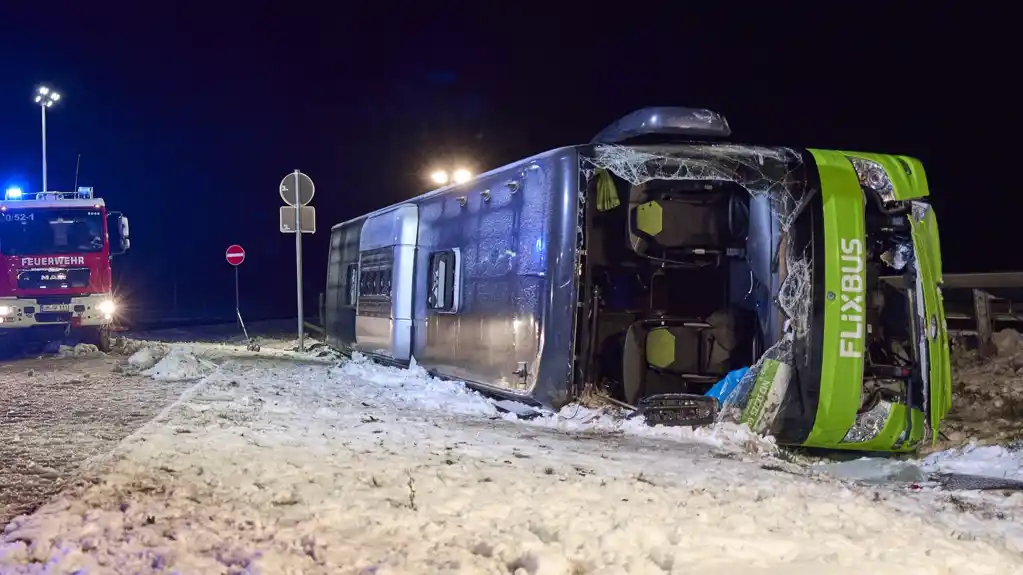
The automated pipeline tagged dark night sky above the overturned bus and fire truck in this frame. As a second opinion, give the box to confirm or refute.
[0,1,1006,318]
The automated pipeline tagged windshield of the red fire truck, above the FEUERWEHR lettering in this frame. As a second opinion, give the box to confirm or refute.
[0,208,103,256]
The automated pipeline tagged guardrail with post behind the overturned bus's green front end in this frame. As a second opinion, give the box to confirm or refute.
[881,271,1023,354]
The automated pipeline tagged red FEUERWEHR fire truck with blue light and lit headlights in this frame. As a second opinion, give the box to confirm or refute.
[0,187,130,352]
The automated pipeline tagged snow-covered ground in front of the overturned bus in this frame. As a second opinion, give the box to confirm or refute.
[0,335,1023,574]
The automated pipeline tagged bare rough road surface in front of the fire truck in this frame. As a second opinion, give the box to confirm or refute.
[0,354,188,526]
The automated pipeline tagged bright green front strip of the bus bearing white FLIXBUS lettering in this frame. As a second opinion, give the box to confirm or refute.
[804,149,866,448]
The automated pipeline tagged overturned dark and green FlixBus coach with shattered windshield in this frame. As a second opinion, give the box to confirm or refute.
[325,107,951,451]
